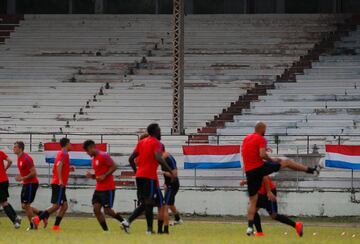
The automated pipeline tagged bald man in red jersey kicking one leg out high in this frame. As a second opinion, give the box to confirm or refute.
[242,122,321,236]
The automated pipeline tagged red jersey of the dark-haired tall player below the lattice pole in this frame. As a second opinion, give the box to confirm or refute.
[134,136,163,181]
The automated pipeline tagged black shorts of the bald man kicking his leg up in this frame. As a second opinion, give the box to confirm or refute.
[246,161,281,196]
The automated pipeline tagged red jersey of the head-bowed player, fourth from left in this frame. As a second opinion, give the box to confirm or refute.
[92,151,115,191]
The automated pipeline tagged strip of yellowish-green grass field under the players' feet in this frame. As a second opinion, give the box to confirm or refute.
[0,217,360,244]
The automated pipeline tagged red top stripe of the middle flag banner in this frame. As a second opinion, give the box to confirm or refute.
[183,145,240,155]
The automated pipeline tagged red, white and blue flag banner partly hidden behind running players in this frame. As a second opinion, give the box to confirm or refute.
[44,142,107,166]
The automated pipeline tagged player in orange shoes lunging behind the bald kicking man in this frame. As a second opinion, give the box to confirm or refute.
[240,176,304,237]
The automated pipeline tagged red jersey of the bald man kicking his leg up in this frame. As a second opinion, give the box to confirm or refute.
[241,133,267,172]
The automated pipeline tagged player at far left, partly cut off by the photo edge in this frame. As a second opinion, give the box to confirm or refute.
[0,151,21,229]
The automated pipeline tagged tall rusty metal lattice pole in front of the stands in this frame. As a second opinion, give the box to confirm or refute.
[172,0,185,135]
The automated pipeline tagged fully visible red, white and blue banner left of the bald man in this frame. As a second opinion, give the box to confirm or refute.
[183,145,241,169]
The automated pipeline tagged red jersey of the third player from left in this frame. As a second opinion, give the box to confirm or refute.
[51,150,70,186]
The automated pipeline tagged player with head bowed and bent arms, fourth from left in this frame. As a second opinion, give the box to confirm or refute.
[83,140,124,231]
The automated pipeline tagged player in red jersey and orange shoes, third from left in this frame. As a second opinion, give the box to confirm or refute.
[32,137,74,231]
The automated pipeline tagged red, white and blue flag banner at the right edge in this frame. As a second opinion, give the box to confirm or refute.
[325,145,360,170]
